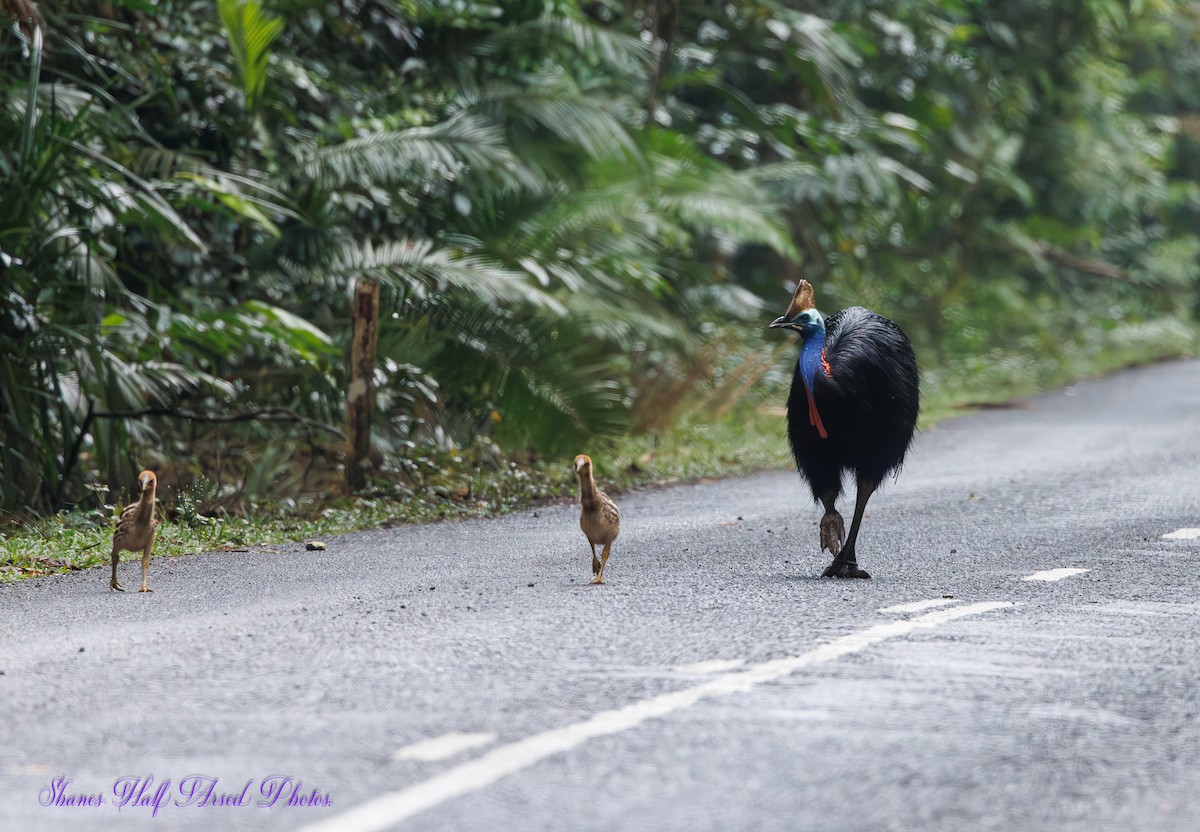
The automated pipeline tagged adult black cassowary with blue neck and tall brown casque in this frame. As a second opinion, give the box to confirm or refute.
[770,280,920,577]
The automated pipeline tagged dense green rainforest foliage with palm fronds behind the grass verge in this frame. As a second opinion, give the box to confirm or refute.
[0,0,1200,511]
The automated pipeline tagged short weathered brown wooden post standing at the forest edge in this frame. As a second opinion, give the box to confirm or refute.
[346,280,379,493]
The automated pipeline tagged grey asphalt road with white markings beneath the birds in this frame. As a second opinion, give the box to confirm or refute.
[0,361,1200,832]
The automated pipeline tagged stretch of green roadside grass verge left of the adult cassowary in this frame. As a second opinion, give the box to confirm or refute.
[0,413,788,581]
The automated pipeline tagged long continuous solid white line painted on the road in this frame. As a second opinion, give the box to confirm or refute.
[301,601,1013,832]
